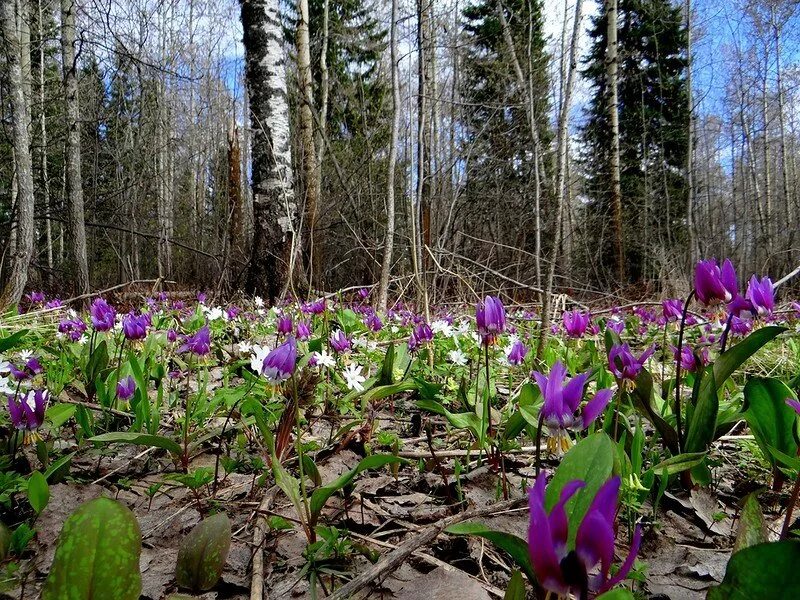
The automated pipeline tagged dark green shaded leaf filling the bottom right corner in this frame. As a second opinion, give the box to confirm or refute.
[706,540,800,600]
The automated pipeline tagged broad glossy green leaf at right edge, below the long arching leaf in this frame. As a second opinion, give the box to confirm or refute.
[742,377,797,467]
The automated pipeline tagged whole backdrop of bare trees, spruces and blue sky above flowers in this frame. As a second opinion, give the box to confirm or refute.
[0,0,800,305]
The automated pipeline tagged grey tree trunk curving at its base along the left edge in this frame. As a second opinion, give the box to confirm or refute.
[0,1,34,309]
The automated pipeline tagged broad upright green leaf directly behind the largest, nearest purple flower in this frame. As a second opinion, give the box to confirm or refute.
[545,432,615,544]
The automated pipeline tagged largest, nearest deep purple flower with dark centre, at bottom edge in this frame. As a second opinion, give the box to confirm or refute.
[528,473,642,598]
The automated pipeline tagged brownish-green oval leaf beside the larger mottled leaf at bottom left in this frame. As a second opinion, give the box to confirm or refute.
[175,513,231,592]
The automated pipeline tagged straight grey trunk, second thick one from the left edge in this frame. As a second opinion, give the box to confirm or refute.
[61,0,89,294]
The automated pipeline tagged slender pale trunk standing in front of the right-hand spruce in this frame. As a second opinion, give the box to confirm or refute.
[606,0,625,285]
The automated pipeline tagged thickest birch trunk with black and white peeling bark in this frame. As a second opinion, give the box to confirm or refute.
[241,0,297,301]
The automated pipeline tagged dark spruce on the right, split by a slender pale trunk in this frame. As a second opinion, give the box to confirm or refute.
[583,0,689,283]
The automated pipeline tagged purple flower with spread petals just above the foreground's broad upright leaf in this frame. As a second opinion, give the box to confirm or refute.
[531,361,612,454]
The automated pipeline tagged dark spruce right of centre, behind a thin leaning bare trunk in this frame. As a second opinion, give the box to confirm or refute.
[460,0,553,260]
